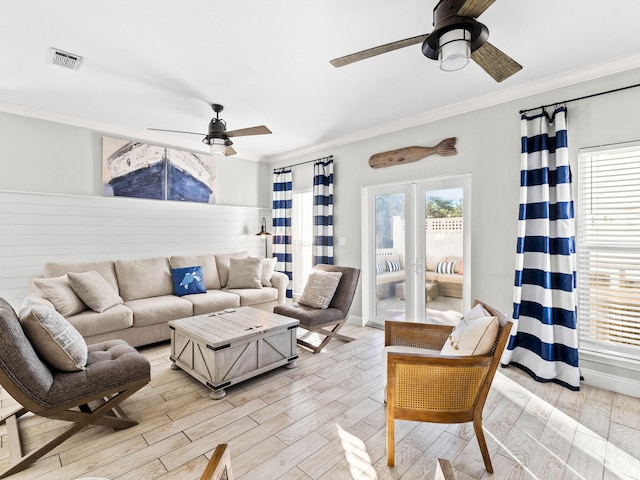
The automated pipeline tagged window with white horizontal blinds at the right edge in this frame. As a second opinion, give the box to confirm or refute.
[578,143,640,359]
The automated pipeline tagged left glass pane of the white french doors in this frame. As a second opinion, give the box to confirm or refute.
[375,193,405,320]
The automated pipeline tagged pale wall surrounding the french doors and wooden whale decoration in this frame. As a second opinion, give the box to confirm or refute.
[273,70,640,394]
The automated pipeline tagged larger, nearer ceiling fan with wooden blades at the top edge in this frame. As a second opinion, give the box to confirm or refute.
[331,0,522,82]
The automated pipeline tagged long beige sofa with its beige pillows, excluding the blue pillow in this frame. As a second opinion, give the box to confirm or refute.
[25,252,288,346]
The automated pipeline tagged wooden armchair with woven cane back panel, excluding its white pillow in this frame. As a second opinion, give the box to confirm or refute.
[385,300,512,473]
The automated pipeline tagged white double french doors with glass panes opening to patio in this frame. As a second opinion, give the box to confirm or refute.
[362,175,471,326]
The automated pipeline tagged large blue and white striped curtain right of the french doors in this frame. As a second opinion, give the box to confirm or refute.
[502,107,580,390]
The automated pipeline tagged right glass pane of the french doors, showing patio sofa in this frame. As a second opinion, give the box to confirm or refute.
[425,188,464,324]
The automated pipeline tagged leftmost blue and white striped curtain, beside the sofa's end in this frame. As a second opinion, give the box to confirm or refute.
[272,168,293,298]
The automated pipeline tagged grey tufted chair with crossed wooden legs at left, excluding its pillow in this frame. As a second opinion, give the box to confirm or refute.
[0,298,150,478]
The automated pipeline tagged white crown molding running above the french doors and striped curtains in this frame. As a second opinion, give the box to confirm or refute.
[264,55,640,163]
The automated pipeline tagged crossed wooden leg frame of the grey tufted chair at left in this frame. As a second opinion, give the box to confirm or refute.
[0,376,149,478]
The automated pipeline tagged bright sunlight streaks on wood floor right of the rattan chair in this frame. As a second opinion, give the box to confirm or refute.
[484,372,640,478]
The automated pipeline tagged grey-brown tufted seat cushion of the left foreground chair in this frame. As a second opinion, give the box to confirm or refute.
[45,340,151,407]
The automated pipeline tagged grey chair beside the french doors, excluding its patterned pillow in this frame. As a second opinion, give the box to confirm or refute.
[273,264,360,353]
